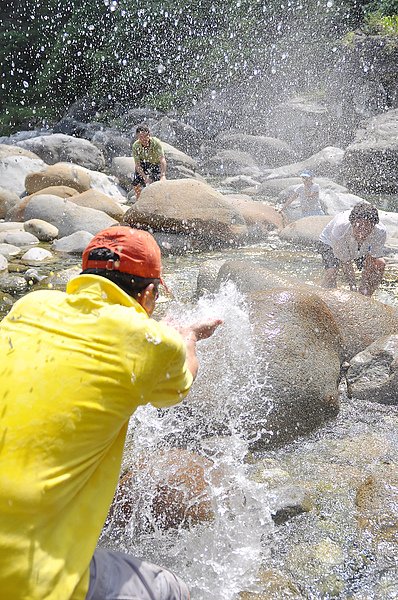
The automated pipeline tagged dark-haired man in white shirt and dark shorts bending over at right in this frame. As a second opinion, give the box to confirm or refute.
[318,202,387,296]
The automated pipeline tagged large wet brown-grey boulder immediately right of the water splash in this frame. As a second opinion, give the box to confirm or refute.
[242,289,341,448]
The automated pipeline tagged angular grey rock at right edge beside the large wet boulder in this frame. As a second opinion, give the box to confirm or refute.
[346,333,398,404]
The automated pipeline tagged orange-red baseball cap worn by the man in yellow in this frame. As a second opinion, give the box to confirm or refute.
[82,226,163,283]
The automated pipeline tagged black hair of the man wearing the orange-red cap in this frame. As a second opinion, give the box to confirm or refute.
[81,248,160,299]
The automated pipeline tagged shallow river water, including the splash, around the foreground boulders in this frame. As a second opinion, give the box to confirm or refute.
[3,236,398,600]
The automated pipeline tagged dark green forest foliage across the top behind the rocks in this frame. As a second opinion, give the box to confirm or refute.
[0,0,396,133]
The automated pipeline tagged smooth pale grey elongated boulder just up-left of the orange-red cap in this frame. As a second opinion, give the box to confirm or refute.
[23,195,117,237]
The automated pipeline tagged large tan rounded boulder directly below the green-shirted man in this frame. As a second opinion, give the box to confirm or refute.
[124,179,246,248]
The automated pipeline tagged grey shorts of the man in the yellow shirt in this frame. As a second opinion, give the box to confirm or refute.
[86,548,190,600]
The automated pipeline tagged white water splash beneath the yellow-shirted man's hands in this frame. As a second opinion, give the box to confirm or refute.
[101,283,272,600]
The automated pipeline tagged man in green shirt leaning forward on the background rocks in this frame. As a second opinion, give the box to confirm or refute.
[133,125,167,200]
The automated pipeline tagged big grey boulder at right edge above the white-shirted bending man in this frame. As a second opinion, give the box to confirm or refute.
[342,109,398,194]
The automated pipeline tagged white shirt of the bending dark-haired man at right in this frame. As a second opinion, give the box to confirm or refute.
[319,210,387,262]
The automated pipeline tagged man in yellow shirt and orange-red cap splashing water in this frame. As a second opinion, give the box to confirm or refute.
[0,226,221,600]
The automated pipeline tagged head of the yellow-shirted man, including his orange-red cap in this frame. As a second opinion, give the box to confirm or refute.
[82,225,163,315]
